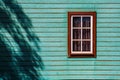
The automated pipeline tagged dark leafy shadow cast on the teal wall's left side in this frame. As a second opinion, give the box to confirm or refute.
[0,0,44,80]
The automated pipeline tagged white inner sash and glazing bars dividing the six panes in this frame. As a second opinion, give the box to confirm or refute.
[71,15,92,53]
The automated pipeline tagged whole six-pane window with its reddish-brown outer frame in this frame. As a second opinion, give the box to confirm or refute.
[68,12,96,57]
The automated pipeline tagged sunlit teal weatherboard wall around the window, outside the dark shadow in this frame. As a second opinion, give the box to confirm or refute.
[18,0,120,80]
